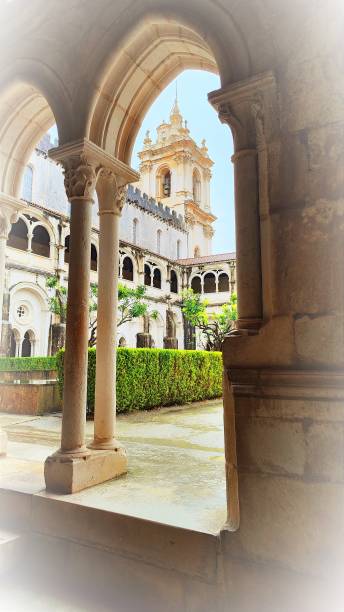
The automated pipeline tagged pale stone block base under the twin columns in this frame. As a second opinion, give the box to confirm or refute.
[44,447,128,494]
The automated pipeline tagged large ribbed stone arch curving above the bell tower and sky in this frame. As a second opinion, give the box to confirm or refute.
[86,0,251,163]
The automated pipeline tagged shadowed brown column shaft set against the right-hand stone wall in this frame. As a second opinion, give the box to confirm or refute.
[232,149,262,330]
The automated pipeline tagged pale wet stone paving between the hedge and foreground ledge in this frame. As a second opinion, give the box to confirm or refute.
[0,401,226,533]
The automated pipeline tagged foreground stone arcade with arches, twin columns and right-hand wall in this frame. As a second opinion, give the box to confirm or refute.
[0,0,344,612]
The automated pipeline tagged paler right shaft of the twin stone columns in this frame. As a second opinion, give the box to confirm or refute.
[92,209,120,448]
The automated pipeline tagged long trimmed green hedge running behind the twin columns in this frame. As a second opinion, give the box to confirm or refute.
[56,348,222,414]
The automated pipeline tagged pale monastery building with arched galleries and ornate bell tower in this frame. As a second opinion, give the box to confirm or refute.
[2,101,235,356]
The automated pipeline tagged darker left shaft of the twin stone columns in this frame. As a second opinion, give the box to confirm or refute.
[61,197,93,455]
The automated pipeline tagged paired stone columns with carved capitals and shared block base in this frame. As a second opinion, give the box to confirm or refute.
[45,139,139,493]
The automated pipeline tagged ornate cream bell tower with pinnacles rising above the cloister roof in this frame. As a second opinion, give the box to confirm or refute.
[139,96,216,257]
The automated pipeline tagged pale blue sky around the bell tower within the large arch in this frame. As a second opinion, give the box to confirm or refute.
[131,70,235,253]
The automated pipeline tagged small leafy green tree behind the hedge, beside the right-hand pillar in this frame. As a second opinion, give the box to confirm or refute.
[182,289,237,351]
